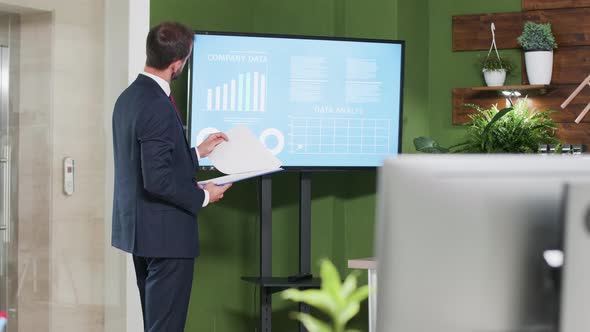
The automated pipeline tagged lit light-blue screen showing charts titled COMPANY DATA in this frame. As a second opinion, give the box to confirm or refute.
[188,32,404,169]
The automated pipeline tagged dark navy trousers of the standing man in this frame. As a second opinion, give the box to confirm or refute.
[133,255,195,332]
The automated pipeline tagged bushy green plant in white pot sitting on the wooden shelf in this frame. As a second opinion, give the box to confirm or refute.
[517,21,557,84]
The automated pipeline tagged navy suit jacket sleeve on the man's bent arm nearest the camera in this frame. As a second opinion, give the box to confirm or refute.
[136,101,205,215]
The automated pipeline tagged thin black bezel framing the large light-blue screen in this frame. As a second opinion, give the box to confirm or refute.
[187,30,406,171]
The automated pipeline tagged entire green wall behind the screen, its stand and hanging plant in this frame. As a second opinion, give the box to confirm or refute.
[150,0,521,332]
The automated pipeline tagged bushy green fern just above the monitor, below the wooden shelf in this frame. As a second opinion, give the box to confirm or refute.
[414,98,559,153]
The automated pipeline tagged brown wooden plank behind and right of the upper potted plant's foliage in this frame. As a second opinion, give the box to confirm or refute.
[518,8,590,48]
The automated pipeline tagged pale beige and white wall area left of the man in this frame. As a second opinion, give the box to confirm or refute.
[0,0,149,332]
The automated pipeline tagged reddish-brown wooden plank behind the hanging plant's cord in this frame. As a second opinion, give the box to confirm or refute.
[453,13,523,51]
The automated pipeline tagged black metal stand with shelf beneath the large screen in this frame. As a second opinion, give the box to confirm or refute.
[241,171,321,332]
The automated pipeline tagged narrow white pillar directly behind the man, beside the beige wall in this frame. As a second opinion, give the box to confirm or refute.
[104,0,149,332]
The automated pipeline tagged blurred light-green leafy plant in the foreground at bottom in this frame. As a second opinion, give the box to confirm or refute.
[281,260,369,332]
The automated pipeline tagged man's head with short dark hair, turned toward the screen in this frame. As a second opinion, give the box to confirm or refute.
[146,22,193,70]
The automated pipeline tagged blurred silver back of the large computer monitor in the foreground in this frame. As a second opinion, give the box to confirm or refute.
[377,155,590,332]
